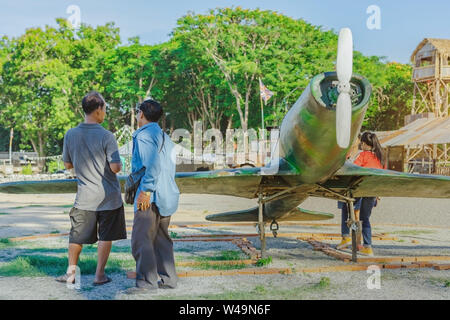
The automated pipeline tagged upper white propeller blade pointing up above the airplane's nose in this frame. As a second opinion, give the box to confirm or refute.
[336,28,353,83]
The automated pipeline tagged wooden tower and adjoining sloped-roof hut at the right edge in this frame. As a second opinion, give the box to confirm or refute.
[377,38,450,176]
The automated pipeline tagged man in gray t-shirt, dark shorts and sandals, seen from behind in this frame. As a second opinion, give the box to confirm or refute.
[56,91,127,285]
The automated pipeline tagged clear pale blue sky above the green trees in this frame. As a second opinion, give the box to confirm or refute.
[0,0,450,63]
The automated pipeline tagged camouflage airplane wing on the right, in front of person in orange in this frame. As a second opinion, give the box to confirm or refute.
[309,162,450,199]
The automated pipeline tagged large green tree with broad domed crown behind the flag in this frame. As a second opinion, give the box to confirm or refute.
[174,7,337,130]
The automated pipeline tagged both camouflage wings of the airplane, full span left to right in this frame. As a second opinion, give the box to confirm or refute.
[0,162,450,199]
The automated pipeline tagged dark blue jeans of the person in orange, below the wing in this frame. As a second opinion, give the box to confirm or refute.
[338,197,376,247]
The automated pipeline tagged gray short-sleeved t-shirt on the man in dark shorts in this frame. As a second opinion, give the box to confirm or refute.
[63,123,123,211]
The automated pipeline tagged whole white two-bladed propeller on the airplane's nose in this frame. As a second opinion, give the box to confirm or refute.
[336,28,353,149]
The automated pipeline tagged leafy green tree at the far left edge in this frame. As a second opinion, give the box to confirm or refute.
[1,27,74,156]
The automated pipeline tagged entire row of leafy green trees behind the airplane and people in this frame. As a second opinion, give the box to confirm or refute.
[0,7,412,156]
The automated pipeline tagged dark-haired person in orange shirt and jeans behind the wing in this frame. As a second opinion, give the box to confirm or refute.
[337,132,385,256]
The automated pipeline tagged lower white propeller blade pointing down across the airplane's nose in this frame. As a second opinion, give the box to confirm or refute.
[336,92,352,149]
